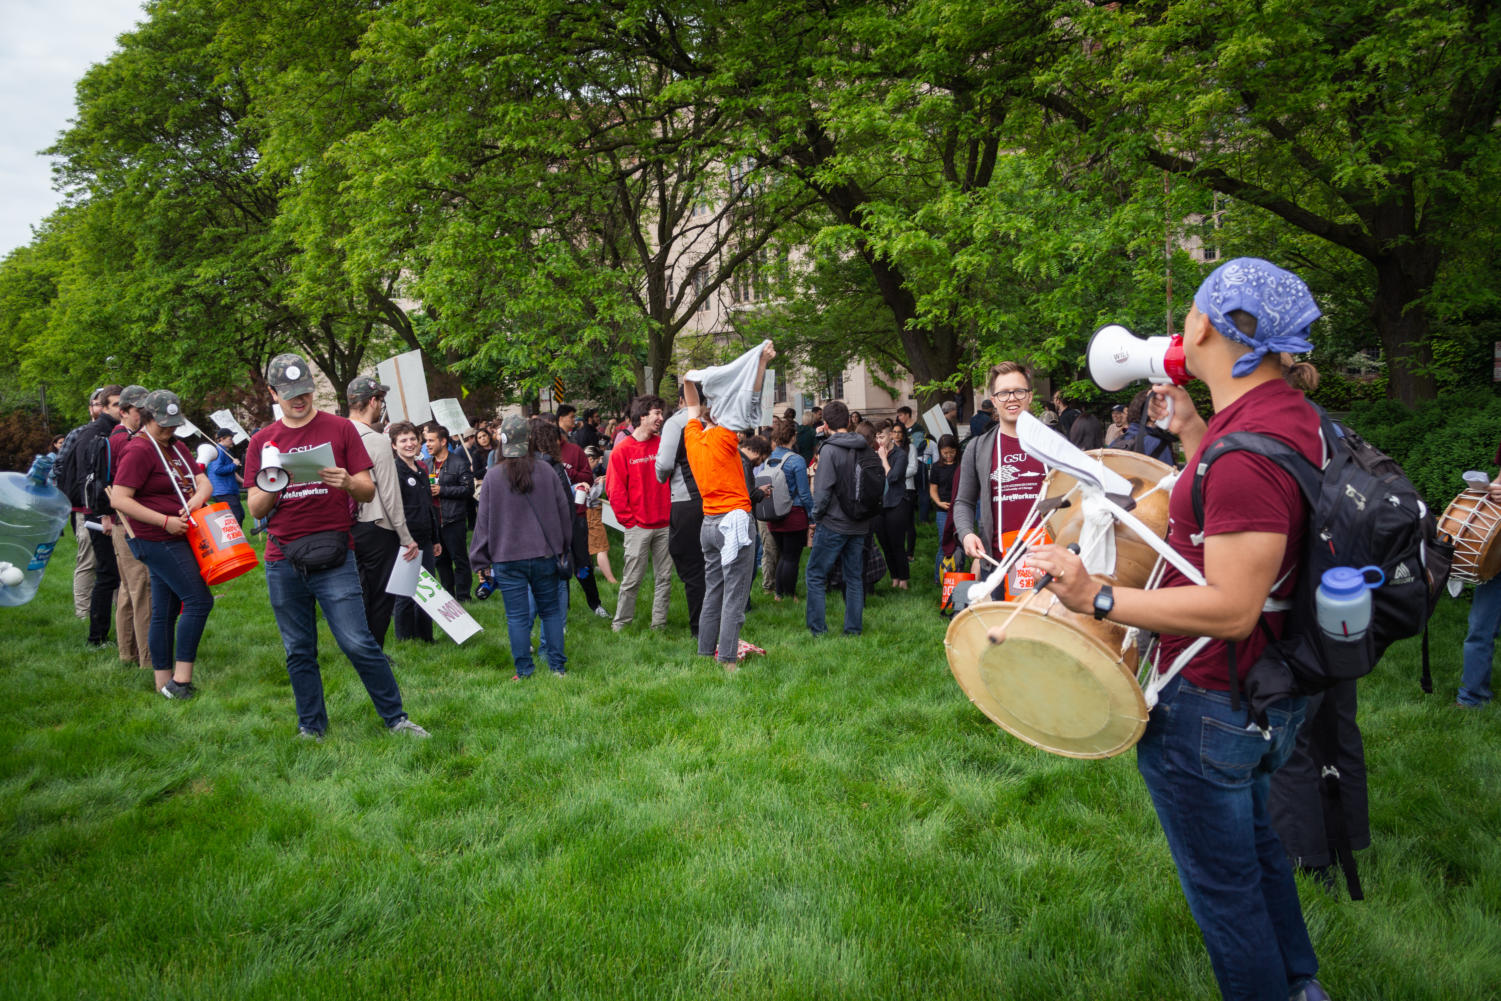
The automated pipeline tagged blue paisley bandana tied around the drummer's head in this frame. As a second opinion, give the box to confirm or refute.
[1193,257,1322,377]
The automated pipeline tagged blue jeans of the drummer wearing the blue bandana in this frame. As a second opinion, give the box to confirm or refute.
[1136,677,1318,1001]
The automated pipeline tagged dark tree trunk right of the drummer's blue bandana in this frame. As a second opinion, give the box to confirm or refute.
[1370,243,1438,407]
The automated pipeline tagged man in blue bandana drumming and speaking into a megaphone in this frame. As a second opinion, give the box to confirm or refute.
[1032,258,1328,1001]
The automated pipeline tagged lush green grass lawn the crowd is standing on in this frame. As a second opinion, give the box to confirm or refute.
[0,527,1501,1001]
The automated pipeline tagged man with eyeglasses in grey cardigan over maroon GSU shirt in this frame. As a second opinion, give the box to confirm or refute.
[953,362,1048,600]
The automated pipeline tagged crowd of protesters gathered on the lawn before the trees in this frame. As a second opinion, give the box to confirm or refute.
[54,347,1174,720]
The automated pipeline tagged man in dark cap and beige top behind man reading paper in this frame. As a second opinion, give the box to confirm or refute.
[345,375,417,650]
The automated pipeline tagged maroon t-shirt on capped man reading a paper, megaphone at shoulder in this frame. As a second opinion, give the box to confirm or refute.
[245,410,374,563]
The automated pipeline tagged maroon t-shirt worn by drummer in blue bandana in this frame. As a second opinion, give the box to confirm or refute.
[1157,380,1324,692]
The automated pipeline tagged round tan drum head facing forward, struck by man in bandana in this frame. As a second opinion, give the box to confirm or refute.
[944,602,1147,758]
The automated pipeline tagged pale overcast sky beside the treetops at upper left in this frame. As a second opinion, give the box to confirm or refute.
[0,0,143,257]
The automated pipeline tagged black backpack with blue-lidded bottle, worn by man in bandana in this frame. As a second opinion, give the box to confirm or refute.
[1193,404,1454,726]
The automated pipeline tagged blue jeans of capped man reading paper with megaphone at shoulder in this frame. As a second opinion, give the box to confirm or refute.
[266,551,407,734]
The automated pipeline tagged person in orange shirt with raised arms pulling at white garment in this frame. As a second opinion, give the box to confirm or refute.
[683,342,776,671]
